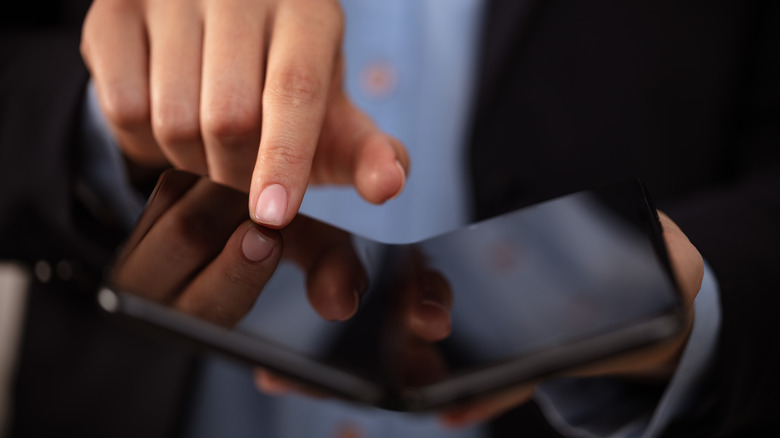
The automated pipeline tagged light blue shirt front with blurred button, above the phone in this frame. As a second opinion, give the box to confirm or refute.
[301,0,483,242]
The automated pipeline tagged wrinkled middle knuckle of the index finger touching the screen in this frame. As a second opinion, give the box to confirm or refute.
[266,66,325,107]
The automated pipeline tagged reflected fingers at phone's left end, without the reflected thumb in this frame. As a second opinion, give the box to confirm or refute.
[111,173,282,327]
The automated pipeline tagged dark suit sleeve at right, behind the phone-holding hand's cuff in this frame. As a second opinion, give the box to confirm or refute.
[644,2,780,436]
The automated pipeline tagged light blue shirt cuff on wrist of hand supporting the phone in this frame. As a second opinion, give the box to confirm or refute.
[535,261,721,438]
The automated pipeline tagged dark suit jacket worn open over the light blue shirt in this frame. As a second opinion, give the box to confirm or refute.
[0,0,780,437]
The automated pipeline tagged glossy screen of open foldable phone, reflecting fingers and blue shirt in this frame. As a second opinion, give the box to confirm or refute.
[109,171,680,409]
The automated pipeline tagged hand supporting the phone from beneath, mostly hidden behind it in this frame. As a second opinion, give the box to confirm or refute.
[441,212,704,427]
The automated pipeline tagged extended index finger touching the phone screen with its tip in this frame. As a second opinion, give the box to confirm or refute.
[249,0,342,228]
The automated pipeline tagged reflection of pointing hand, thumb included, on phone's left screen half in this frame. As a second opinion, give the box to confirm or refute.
[111,171,376,327]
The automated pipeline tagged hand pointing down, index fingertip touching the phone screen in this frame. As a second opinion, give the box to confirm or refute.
[81,0,409,228]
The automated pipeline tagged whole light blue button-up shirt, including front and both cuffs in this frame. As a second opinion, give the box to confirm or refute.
[83,0,720,438]
